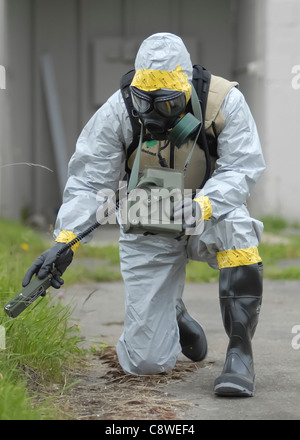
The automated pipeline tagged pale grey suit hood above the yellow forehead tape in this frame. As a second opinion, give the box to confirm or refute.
[135,32,193,84]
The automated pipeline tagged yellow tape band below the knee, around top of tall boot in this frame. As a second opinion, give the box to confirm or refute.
[217,247,262,269]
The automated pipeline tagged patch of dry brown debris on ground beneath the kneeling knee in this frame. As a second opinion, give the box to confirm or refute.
[60,347,209,420]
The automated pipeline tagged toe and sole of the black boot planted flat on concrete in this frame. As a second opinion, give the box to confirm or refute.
[214,373,254,397]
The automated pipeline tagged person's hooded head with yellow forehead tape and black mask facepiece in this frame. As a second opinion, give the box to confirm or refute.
[131,33,193,140]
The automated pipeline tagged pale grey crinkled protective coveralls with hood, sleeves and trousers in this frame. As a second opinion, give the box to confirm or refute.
[54,33,265,375]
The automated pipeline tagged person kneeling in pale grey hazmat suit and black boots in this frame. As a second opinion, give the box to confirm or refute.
[23,33,265,396]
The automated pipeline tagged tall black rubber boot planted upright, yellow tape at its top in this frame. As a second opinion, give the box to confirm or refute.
[214,263,263,397]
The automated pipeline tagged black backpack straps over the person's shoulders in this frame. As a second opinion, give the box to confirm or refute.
[120,65,218,188]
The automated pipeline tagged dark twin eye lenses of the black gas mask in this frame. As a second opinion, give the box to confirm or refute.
[131,87,186,118]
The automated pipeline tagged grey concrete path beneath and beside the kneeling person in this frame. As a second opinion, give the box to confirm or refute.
[63,280,300,420]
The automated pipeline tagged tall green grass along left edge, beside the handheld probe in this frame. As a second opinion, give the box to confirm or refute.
[0,219,82,420]
